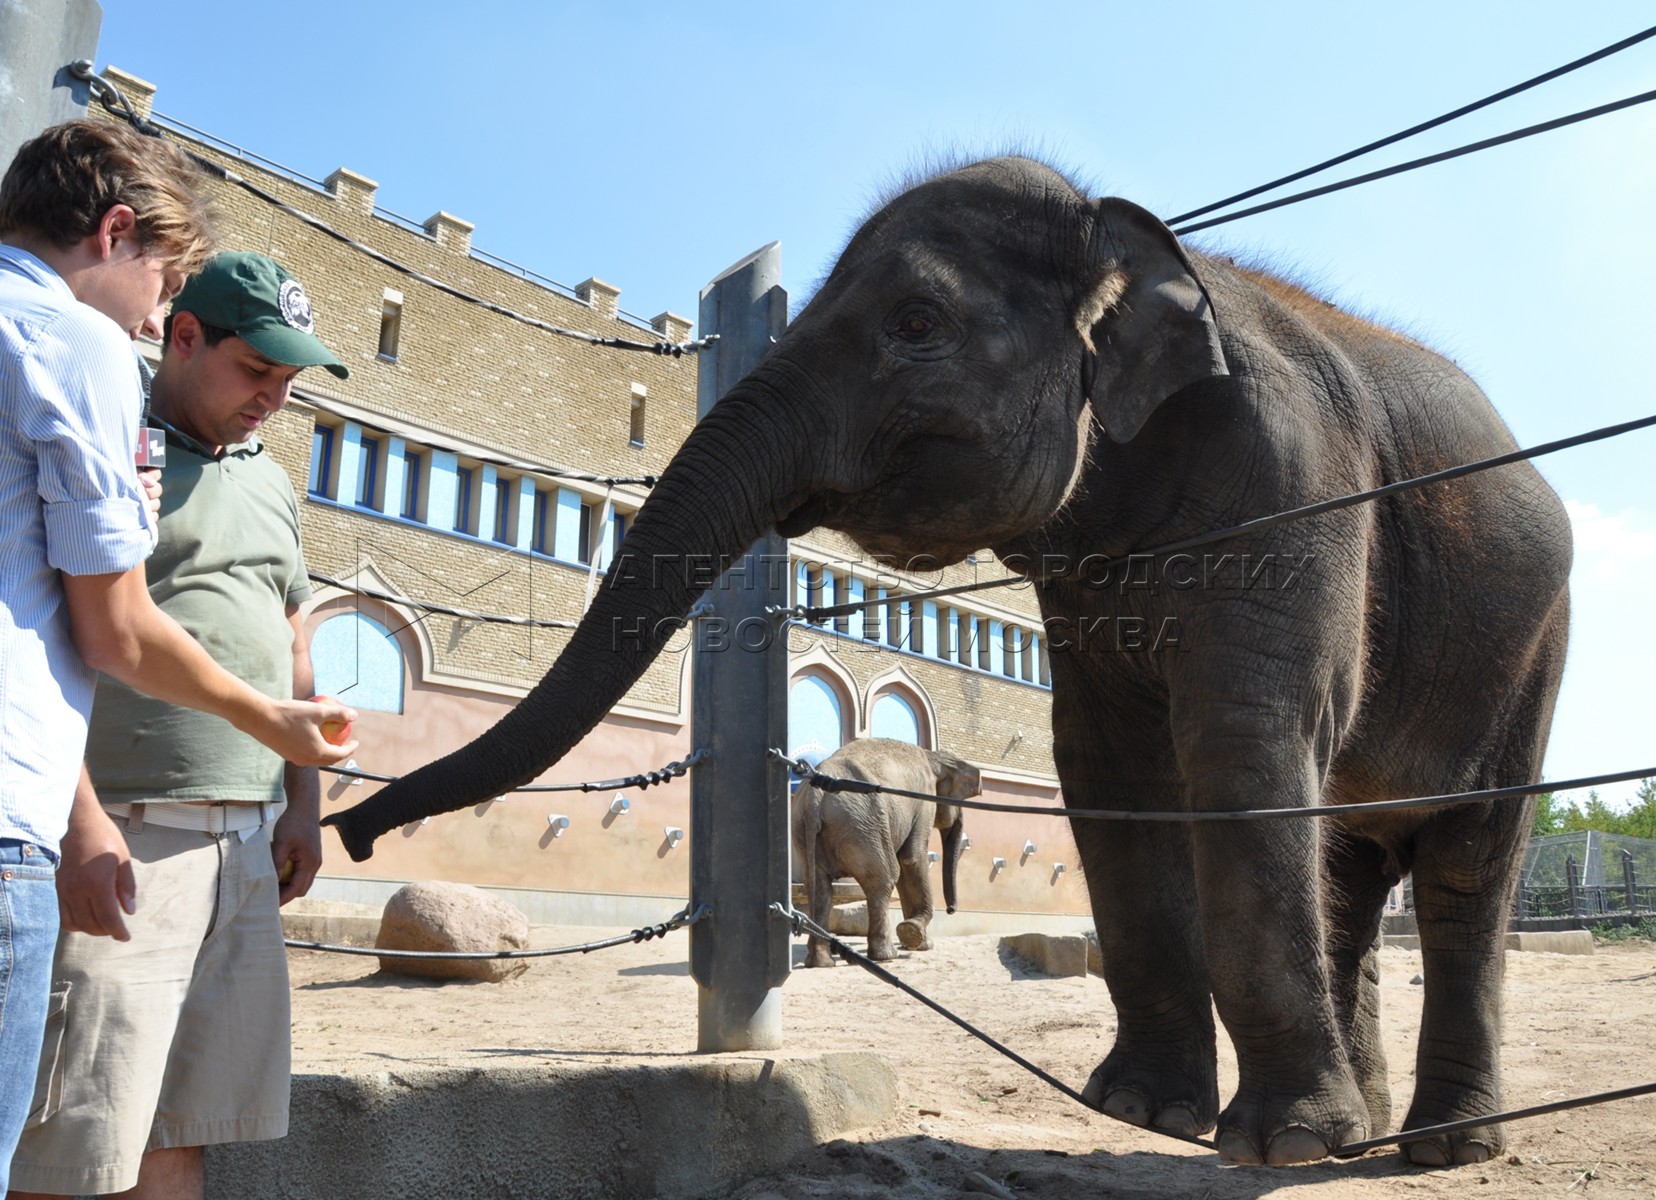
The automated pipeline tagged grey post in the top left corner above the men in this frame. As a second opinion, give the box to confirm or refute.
[0,0,103,172]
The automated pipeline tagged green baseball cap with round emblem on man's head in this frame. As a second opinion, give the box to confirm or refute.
[172,250,351,379]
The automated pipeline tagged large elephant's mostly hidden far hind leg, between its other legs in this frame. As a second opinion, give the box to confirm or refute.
[1323,824,1398,1137]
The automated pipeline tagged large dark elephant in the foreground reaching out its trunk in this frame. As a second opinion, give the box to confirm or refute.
[330,156,1572,1165]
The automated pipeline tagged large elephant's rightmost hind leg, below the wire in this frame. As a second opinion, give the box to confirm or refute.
[1403,794,1532,1167]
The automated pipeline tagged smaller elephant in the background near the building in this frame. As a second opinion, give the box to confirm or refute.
[793,738,984,967]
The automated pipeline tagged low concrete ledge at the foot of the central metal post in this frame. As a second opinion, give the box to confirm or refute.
[207,1051,898,1200]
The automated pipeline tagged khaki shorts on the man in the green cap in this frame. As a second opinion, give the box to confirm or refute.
[12,806,291,1195]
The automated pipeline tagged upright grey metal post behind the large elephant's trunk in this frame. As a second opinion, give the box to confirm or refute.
[691,242,790,1051]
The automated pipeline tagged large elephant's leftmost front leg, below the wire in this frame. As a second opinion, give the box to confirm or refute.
[1065,775,1219,1135]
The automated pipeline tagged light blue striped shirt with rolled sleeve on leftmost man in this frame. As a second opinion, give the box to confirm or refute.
[0,245,154,854]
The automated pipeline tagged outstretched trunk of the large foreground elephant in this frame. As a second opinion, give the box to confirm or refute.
[323,381,813,862]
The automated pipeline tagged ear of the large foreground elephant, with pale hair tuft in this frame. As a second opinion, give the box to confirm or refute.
[1075,197,1230,442]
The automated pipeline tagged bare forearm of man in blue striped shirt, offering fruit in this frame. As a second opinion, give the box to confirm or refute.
[63,564,356,765]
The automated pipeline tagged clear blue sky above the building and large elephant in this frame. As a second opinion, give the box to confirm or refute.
[98,0,1656,799]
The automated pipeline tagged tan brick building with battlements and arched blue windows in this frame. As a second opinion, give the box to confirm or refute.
[108,68,1086,930]
